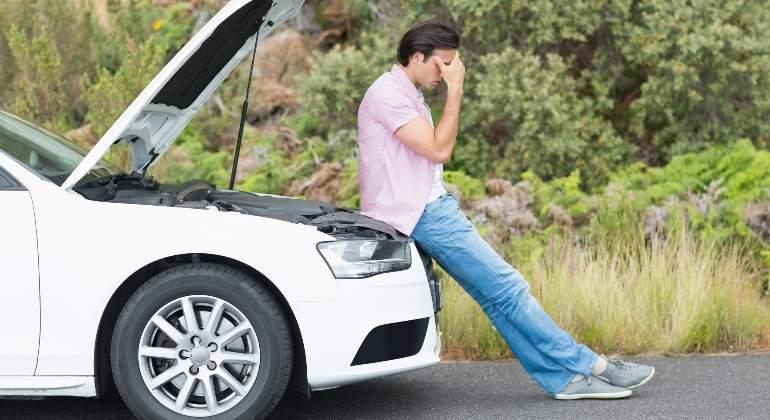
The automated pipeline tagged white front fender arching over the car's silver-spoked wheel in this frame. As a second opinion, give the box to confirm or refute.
[30,182,337,375]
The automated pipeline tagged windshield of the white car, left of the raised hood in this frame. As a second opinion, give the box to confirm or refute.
[0,111,121,185]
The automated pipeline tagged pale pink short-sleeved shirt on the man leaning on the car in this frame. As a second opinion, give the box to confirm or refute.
[358,64,436,235]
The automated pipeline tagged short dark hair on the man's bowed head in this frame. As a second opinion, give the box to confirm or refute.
[398,20,460,66]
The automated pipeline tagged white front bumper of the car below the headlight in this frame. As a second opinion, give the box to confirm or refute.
[294,243,441,390]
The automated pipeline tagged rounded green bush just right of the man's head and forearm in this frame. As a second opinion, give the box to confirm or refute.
[455,48,631,185]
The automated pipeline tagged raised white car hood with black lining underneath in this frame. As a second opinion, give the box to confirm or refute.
[62,0,304,189]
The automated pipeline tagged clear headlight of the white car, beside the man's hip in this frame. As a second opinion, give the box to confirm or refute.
[316,239,412,279]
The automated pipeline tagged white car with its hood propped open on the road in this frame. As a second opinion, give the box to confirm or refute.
[0,0,441,419]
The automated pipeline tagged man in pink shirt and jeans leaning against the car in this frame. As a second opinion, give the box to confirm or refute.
[358,21,654,399]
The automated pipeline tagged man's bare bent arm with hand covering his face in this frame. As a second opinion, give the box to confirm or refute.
[395,53,465,163]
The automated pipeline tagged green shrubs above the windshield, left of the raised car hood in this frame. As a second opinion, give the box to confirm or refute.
[0,0,192,135]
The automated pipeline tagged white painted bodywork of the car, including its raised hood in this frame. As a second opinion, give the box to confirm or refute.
[0,0,440,404]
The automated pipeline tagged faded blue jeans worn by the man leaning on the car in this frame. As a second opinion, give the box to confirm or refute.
[412,194,598,395]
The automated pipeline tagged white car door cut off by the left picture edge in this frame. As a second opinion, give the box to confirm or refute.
[0,167,40,376]
